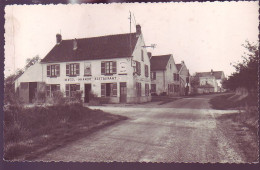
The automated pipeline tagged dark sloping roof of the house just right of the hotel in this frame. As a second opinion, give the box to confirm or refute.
[150,54,171,71]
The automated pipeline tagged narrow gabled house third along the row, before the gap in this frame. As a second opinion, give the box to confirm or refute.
[176,61,191,95]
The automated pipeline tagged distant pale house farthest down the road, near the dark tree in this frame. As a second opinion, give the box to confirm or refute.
[195,70,225,93]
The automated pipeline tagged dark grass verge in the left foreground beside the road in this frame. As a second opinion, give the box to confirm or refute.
[4,104,127,160]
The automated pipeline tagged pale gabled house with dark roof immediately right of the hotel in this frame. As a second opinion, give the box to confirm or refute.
[151,54,180,96]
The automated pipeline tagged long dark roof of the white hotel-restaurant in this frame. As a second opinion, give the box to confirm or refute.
[42,33,138,62]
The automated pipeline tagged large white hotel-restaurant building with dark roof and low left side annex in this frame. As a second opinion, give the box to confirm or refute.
[15,25,151,103]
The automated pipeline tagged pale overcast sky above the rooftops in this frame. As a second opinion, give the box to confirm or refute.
[5,1,258,75]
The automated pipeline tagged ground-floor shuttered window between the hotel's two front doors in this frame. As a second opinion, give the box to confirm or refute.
[101,83,117,97]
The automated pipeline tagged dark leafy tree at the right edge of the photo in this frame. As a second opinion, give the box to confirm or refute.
[223,41,259,91]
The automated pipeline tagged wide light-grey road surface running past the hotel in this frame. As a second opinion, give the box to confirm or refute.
[37,96,244,163]
